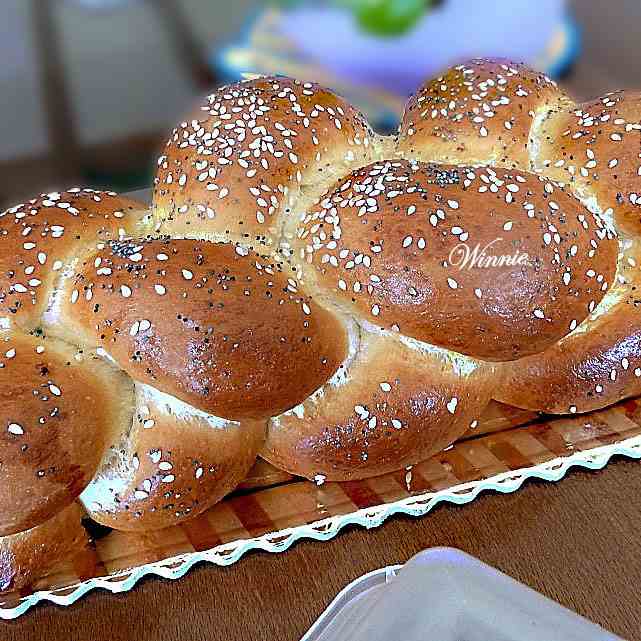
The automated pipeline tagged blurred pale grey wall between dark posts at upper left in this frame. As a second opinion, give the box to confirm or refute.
[0,0,254,160]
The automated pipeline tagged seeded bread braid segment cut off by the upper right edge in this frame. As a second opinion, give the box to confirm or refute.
[534,91,641,235]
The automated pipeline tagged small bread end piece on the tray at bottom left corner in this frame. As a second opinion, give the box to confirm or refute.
[0,503,88,592]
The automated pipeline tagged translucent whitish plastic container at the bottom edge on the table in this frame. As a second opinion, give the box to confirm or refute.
[302,548,622,641]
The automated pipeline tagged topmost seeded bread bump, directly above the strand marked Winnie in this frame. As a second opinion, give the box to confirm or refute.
[398,59,570,169]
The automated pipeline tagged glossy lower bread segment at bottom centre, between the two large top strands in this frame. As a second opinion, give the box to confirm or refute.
[261,327,496,482]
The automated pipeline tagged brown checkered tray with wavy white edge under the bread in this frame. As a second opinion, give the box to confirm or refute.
[0,400,641,619]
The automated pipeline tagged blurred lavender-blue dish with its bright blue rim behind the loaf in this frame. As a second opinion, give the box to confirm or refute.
[212,0,580,130]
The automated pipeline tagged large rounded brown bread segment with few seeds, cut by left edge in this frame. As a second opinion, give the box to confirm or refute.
[0,332,132,536]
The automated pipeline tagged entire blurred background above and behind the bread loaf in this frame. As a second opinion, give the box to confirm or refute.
[0,0,641,208]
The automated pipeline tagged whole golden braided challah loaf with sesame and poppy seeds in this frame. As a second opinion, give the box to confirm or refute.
[0,60,641,587]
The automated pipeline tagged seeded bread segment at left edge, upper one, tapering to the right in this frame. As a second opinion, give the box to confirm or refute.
[0,189,146,329]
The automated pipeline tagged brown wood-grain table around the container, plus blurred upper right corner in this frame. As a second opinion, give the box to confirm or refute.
[5,0,641,641]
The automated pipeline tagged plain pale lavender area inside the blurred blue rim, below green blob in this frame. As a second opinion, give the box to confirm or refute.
[281,0,566,95]
